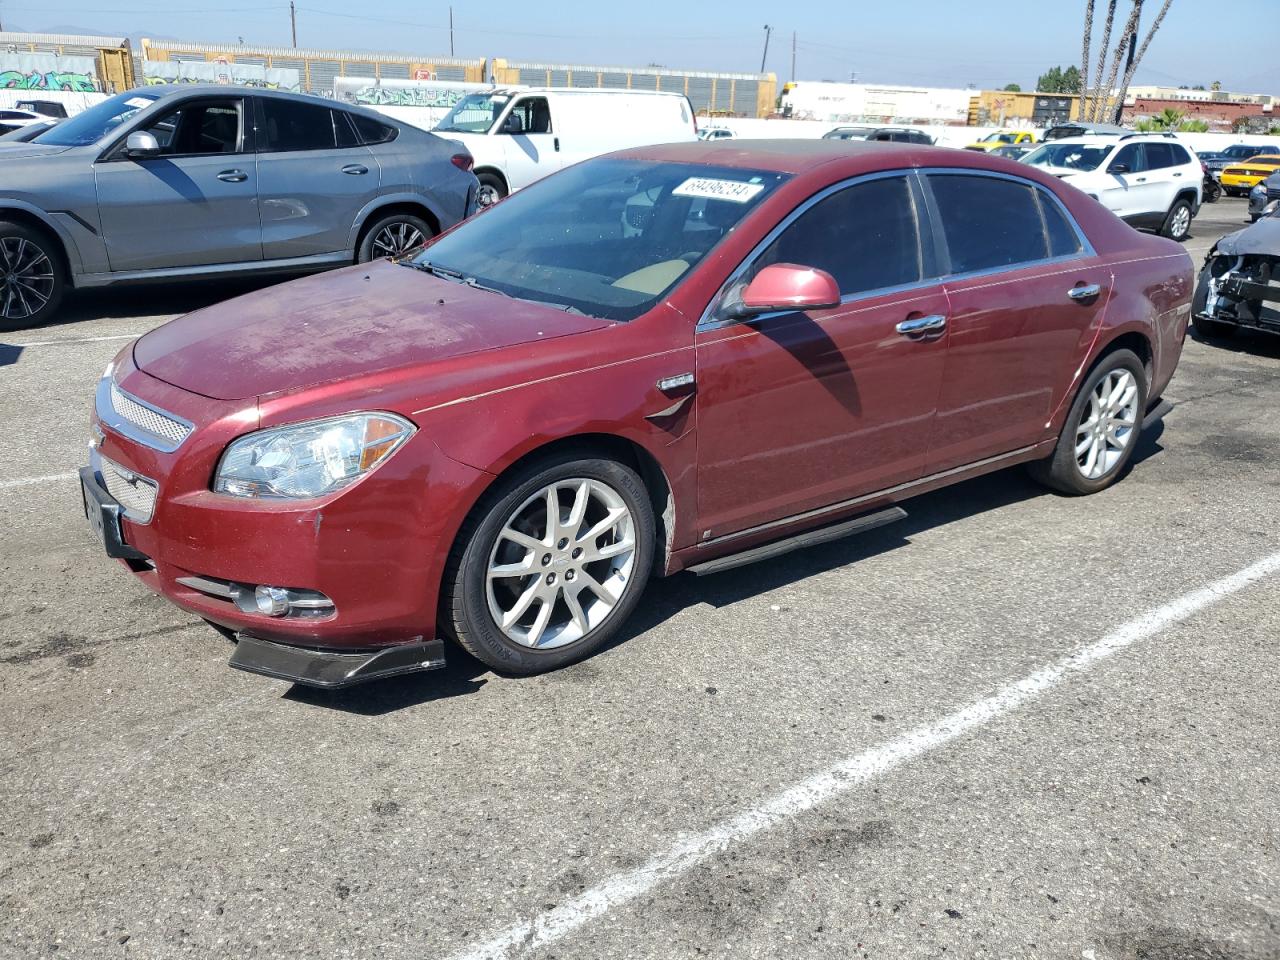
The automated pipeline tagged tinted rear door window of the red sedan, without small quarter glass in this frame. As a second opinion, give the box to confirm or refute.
[929,174,1050,274]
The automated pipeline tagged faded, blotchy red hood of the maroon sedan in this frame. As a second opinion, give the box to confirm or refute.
[133,261,609,401]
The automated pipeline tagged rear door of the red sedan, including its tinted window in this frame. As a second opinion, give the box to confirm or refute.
[925,170,1111,474]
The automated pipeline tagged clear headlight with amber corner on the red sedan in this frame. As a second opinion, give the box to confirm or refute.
[214,413,415,499]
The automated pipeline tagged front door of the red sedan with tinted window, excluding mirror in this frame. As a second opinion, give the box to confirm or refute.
[695,174,946,540]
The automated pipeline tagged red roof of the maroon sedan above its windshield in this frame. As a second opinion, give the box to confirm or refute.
[613,137,973,174]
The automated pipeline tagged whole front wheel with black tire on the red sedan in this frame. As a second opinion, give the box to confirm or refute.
[440,452,655,675]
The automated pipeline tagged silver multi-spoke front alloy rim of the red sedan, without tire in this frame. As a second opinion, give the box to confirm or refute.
[485,477,636,650]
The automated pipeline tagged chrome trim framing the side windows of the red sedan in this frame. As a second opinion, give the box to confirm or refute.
[694,166,1097,333]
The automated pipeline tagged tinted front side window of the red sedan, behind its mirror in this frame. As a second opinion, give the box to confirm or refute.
[754,177,923,297]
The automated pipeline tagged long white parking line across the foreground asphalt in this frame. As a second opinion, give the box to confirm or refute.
[453,553,1280,960]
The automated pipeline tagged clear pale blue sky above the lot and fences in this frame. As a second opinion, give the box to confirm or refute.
[0,0,1280,95]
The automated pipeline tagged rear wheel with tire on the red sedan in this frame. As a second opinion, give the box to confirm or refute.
[1030,349,1147,495]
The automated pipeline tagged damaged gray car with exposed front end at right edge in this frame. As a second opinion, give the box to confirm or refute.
[1192,211,1280,337]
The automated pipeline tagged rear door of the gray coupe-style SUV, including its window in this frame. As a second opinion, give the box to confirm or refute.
[255,96,381,260]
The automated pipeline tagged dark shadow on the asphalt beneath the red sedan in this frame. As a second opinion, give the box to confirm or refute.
[294,440,1164,716]
